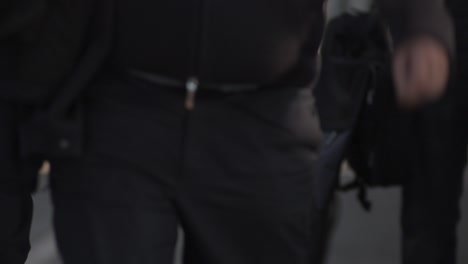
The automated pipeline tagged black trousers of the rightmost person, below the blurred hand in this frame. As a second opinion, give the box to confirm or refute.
[401,79,468,264]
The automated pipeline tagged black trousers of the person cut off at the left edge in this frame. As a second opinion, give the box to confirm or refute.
[0,99,40,264]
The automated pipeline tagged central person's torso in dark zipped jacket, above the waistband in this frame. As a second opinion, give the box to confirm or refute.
[112,0,322,83]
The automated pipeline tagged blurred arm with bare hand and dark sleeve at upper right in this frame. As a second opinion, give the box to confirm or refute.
[378,0,455,109]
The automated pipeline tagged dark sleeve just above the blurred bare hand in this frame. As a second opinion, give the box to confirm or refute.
[378,0,455,57]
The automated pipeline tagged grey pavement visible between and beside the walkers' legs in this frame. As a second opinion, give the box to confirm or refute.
[26,166,468,264]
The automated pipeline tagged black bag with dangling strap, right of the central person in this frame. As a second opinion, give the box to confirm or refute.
[314,12,413,209]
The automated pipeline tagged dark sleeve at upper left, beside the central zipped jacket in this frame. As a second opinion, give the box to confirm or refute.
[17,0,96,84]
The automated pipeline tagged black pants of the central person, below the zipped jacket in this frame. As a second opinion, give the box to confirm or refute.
[51,73,320,264]
